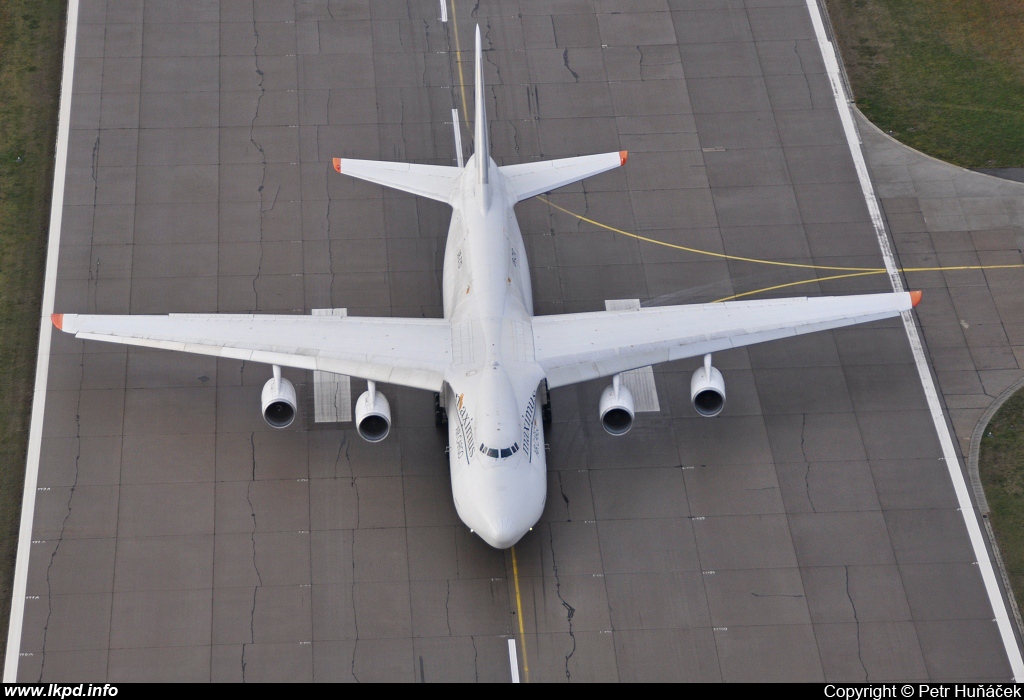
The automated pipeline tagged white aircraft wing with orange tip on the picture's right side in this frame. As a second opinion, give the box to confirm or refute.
[534,292,921,388]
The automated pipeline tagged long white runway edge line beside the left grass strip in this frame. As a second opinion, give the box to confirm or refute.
[3,0,79,683]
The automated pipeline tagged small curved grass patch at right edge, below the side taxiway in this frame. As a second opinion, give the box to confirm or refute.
[978,391,1024,609]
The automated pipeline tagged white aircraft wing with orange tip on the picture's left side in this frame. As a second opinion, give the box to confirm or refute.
[53,313,452,391]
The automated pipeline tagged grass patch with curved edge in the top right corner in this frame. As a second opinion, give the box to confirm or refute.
[826,0,1024,168]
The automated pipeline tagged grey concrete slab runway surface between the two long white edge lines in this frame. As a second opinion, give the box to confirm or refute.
[4,0,1020,682]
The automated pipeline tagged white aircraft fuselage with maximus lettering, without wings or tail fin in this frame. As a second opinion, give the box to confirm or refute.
[443,151,547,549]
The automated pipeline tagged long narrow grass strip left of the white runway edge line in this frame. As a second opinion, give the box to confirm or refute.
[0,0,67,659]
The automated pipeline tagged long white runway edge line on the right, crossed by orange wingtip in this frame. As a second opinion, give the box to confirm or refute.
[806,0,1024,683]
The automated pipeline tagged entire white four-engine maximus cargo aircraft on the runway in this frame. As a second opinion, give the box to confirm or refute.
[53,27,921,549]
